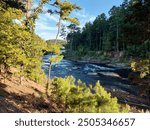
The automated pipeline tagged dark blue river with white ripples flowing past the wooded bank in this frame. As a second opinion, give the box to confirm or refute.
[42,54,147,107]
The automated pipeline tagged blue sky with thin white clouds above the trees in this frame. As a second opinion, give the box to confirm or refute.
[33,0,123,40]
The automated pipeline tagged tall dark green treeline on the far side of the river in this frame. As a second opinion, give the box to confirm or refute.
[67,0,150,57]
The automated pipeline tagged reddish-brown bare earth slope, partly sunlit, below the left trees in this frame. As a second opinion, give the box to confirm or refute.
[0,75,60,113]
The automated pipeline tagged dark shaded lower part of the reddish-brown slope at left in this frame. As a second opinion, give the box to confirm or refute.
[0,83,63,113]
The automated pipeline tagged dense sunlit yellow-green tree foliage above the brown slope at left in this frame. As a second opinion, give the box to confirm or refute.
[0,8,46,82]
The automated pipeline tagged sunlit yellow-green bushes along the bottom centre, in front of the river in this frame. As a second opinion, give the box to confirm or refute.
[53,76,128,112]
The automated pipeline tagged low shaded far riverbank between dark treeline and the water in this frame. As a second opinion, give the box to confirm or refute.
[64,51,132,68]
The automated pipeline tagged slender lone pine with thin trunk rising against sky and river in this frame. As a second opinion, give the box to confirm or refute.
[47,0,80,88]
